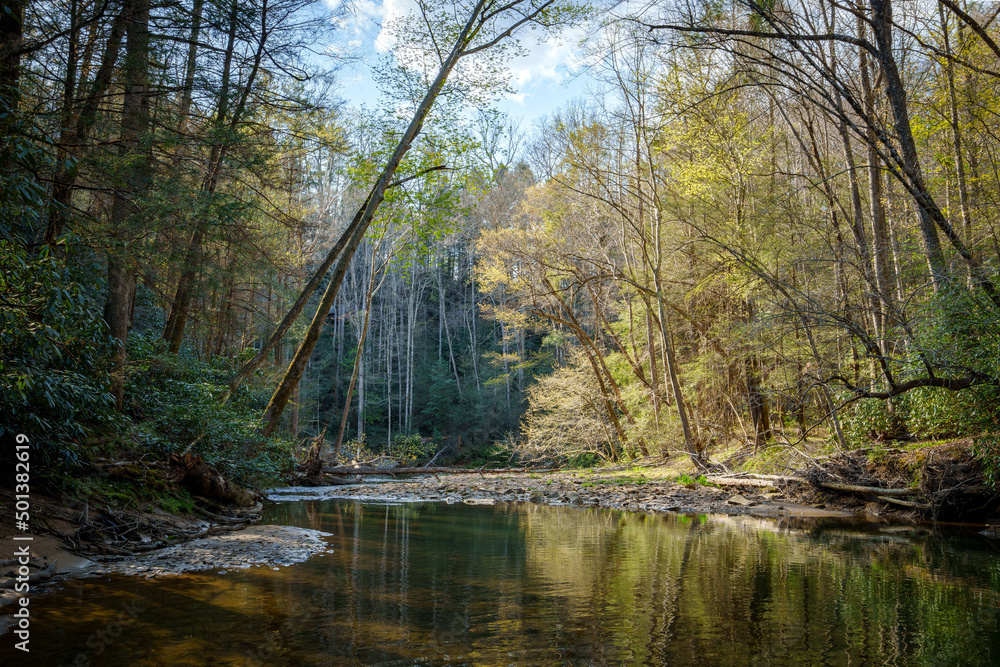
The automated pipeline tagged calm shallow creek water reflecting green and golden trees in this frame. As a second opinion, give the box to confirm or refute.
[0,500,1000,666]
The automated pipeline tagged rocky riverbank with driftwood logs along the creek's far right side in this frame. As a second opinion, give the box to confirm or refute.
[293,438,1000,526]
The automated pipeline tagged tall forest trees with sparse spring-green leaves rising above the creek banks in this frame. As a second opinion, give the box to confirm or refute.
[0,0,1000,481]
